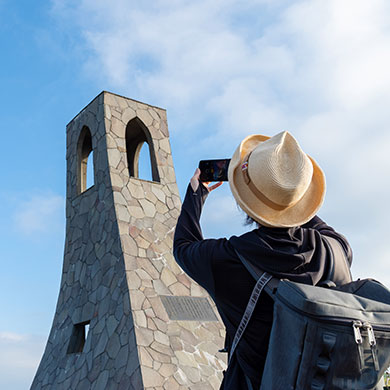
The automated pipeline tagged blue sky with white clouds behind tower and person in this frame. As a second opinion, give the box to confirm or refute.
[0,0,390,390]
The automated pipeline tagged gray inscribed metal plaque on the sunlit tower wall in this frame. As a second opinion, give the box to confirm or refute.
[161,295,218,321]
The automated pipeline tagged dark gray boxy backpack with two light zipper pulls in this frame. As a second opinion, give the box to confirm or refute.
[233,236,390,390]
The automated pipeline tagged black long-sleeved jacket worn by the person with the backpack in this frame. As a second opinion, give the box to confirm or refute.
[173,184,352,390]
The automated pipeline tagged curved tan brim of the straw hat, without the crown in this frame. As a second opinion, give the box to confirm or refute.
[228,134,326,227]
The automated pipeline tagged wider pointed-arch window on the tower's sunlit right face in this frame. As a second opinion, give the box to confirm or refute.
[126,118,160,182]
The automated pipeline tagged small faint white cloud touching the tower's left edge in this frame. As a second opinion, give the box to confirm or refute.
[13,194,64,235]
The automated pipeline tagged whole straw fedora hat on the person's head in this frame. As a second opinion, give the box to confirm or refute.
[228,131,325,227]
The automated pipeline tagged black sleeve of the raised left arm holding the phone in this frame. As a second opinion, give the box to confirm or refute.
[173,183,226,296]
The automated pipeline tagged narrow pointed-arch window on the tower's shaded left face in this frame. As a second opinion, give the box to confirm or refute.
[77,126,95,194]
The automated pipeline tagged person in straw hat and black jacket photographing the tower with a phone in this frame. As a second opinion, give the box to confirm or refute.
[173,131,352,390]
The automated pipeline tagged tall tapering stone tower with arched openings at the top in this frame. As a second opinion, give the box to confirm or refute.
[31,92,226,390]
